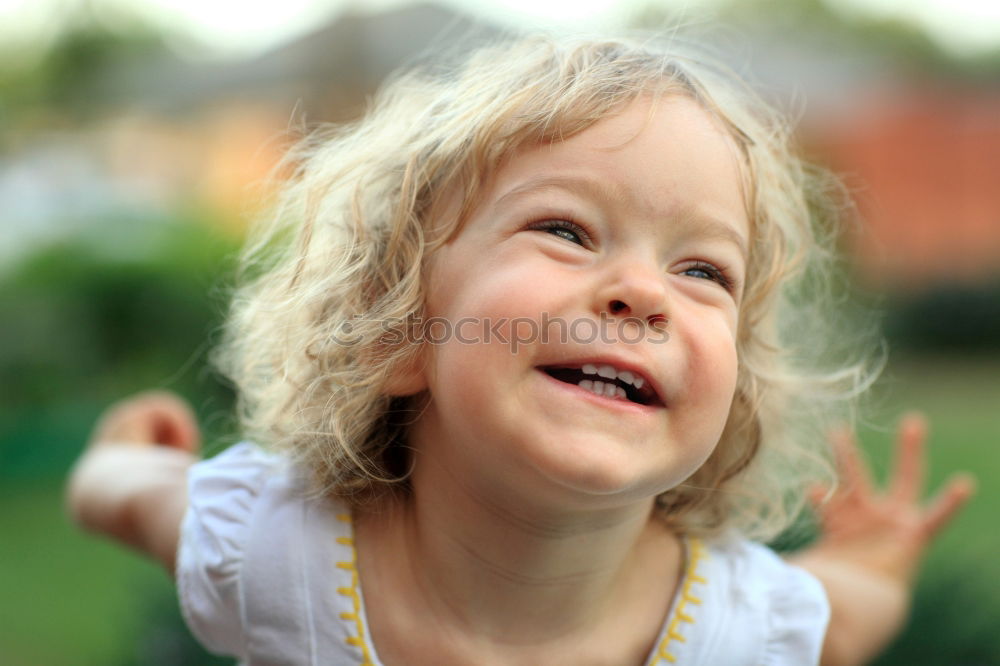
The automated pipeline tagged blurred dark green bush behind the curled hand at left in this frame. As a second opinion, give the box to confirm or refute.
[0,215,235,479]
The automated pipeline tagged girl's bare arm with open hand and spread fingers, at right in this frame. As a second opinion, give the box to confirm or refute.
[789,414,974,666]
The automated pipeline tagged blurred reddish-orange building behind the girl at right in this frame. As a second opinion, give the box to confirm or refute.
[816,82,1000,290]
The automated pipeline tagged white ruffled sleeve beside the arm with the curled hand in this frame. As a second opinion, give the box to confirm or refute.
[176,444,279,658]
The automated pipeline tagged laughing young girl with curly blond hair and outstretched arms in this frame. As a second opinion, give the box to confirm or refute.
[69,33,971,666]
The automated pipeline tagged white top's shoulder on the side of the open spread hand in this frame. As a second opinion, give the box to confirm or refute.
[654,537,830,666]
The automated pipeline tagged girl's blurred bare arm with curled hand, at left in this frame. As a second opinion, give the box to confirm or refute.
[66,392,200,575]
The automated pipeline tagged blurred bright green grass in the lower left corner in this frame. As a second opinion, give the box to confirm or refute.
[0,479,172,666]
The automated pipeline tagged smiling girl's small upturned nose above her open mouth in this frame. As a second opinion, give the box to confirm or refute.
[594,255,669,324]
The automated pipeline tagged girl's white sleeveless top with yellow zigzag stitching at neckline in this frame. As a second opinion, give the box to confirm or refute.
[177,444,830,666]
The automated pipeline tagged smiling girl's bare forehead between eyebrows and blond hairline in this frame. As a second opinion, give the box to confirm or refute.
[483,95,749,237]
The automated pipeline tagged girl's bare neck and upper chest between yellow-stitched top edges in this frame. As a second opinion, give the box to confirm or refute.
[361,448,682,659]
